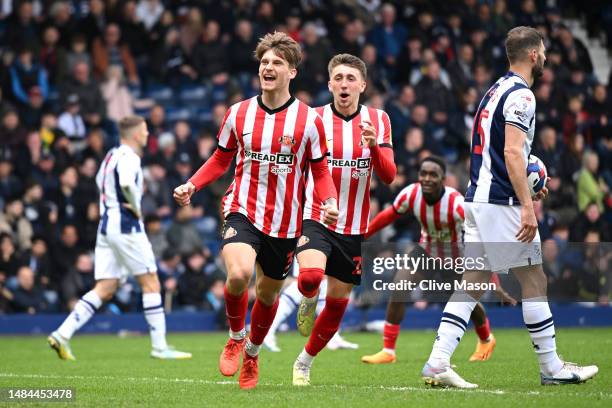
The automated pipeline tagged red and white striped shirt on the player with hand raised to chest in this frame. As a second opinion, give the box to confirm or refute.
[304,104,391,235]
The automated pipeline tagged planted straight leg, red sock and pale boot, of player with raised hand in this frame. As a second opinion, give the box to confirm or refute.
[293,276,353,385]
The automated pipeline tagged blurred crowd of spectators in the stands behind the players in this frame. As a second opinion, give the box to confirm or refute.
[0,0,612,313]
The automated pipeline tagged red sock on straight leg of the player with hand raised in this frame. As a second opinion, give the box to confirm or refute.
[304,296,348,356]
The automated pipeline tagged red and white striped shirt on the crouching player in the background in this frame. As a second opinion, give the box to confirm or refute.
[393,183,464,245]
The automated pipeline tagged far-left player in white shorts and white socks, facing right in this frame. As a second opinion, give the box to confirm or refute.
[47,116,191,360]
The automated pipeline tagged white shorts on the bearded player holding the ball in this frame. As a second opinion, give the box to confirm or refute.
[463,202,542,273]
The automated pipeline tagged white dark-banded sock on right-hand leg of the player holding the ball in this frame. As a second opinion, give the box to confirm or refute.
[523,297,563,376]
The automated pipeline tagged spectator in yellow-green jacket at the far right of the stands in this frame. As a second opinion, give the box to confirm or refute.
[577,150,608,212]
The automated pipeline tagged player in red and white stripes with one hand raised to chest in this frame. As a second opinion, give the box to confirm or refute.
[293,54,396,385]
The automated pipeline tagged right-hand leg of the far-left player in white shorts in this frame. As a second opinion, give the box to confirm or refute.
[136,272,191,360]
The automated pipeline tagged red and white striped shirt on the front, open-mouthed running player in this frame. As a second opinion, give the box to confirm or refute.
[218,97,327,238]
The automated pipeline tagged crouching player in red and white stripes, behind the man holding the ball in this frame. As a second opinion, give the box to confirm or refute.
[361,156,516,364]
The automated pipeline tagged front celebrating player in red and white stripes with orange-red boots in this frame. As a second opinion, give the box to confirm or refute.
[174,32,338,389]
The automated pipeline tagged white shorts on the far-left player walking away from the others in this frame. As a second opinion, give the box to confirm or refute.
[94,232,157,280]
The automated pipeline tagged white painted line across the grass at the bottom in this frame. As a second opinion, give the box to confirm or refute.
[0,373,612,399]
